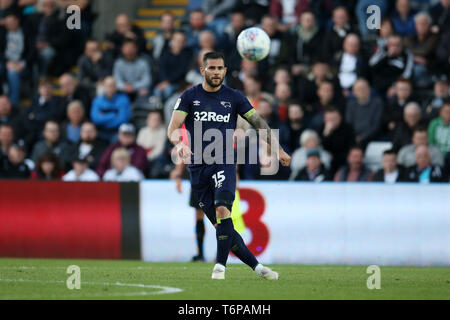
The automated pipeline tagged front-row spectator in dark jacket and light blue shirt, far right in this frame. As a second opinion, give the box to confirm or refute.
[406,145,448,183]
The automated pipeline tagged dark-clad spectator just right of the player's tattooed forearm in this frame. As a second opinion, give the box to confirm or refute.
[280,101,306,153]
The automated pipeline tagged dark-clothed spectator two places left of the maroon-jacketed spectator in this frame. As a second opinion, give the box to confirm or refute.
[31,120,67,163]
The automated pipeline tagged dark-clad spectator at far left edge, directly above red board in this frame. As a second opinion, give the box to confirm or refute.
[0,143,31,179]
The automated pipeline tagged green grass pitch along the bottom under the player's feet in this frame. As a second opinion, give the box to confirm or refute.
[0,259,450,300]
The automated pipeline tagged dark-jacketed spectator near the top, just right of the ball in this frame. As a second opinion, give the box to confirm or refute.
[290,10,323,76]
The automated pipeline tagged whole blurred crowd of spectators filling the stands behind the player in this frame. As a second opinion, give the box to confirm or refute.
[0,0,450,183]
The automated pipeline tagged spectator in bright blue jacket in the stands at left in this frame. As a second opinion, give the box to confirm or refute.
[91,77,131,142]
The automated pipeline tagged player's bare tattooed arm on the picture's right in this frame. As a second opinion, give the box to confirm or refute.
[244,109,291,167]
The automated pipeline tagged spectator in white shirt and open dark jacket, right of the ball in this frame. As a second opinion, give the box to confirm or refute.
[333,33,368,90]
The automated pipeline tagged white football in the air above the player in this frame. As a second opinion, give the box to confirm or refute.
[236,27,270,61]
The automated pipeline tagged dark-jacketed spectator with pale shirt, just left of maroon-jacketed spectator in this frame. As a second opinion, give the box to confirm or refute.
[61,122,108,171]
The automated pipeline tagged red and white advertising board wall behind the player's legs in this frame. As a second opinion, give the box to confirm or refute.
[0,181,450,266]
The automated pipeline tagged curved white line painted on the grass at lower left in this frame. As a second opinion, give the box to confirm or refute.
[0,279,183,300]
